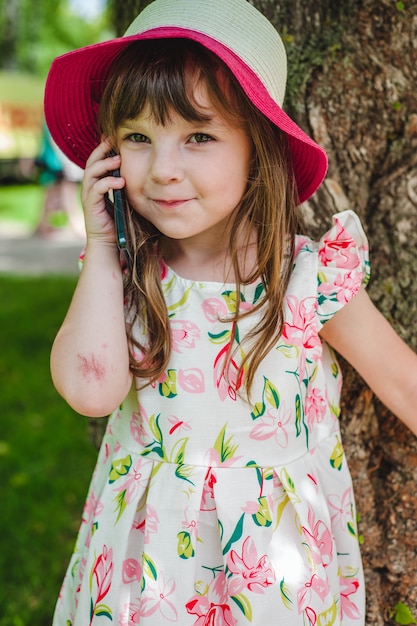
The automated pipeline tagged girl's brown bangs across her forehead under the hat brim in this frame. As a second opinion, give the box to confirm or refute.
[99,39,242,137]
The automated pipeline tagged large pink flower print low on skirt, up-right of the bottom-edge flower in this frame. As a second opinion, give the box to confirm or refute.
[227,537,275,596]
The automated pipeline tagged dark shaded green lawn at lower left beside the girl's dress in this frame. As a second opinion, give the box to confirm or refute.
[0,276,96,626]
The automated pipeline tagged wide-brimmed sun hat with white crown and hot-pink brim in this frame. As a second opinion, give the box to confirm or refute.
[45,0,327,202]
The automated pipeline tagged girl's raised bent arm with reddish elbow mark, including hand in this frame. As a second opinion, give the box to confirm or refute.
[51,142,132,417]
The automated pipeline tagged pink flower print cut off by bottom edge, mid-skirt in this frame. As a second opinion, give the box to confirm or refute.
[185,572,237,626]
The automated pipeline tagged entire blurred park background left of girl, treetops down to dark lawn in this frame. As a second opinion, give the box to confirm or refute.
[0,0,110,626]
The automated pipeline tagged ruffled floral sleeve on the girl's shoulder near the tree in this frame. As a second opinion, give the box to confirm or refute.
[316,210,370,330]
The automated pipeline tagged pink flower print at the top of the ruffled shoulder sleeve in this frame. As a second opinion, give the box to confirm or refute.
[319,220,360,270]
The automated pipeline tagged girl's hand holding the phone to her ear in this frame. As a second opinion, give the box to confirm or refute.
[81,140,125,244]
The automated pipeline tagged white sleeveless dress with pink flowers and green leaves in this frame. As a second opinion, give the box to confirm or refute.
[53,211,369,626]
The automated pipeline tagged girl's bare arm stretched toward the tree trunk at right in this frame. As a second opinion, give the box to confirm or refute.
[320,287,417,435]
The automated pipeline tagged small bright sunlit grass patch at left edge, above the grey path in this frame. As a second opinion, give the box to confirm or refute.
[0,185,45,230]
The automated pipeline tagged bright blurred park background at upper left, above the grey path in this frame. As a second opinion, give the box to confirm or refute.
[0,0,110,236]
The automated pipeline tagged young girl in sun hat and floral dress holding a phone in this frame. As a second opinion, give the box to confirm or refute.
[45,0,417,626]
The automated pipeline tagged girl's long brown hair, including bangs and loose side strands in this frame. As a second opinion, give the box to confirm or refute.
[99,39,301,394]
